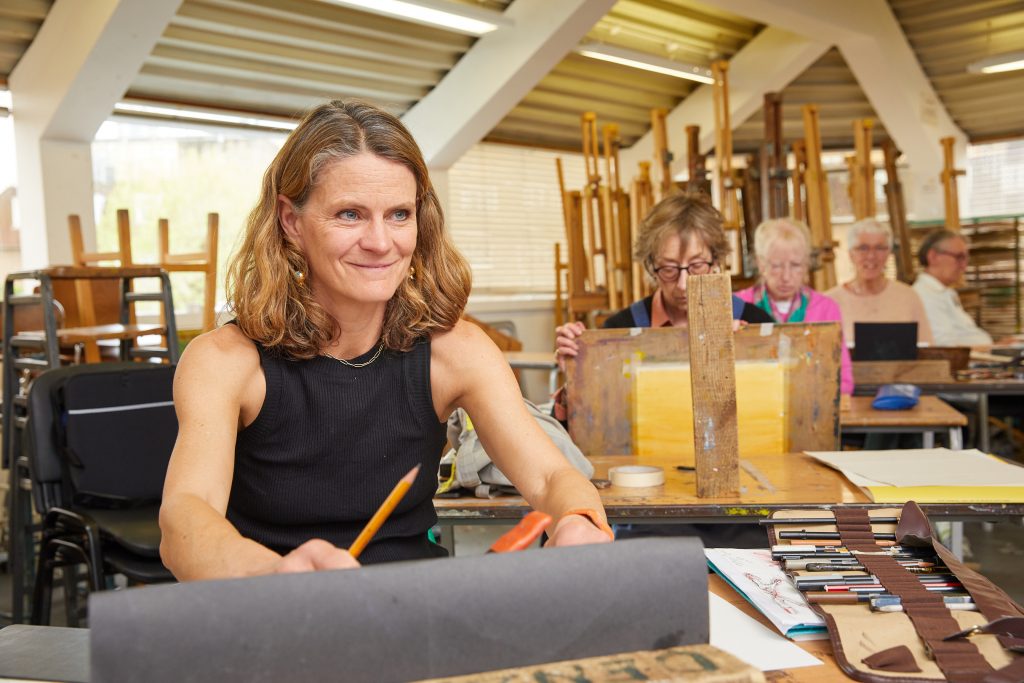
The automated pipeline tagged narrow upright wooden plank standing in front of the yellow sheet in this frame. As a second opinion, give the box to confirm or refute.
[687,273,739,498]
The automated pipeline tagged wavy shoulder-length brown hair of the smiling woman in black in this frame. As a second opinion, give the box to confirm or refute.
[227,100,472,358]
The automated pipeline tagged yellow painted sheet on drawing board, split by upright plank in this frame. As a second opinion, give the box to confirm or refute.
[632,360,788,467]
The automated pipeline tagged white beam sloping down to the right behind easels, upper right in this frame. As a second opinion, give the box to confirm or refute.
[716,0,967,218]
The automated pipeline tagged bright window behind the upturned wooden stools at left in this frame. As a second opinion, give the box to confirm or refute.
[92,120,285,327]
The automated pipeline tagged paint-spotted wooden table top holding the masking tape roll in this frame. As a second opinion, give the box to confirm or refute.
[434,453,1024,523]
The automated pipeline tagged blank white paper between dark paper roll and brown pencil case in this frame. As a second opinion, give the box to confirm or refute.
[708,593,821,671]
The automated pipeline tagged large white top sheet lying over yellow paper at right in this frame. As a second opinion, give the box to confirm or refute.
[805,449,1024,486]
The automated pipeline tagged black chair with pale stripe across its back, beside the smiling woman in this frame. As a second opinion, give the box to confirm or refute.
[25,362,178,625]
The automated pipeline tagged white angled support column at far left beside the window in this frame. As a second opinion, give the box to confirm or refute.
[8,0,181,268]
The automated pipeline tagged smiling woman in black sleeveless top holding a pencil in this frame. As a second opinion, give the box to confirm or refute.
[161,101,611,580]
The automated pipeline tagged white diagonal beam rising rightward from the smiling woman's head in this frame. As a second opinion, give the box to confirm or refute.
[402,0,614,169]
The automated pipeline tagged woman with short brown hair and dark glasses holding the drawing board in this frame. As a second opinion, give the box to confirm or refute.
[555,195,772,365]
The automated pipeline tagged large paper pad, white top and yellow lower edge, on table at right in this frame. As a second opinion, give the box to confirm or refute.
[805,449,1024,503]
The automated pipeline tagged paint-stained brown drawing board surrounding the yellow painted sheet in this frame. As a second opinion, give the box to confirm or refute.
[566,323,840,456]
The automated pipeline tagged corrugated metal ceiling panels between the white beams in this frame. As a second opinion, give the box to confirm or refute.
[0,0,1024,151]
